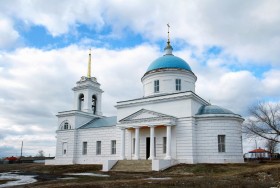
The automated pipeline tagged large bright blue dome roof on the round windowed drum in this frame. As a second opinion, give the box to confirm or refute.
[147,54,191,72]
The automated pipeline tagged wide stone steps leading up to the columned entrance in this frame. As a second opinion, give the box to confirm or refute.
[111,160,152,172]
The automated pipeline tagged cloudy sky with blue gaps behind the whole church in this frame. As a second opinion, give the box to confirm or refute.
[0,0,280,157]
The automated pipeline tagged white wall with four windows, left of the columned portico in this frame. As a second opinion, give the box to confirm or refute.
[50,126,123,164]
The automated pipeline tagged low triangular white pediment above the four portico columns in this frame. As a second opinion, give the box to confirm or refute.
[120,109,174,122]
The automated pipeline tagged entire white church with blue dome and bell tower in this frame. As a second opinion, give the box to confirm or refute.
[46,33,244,171]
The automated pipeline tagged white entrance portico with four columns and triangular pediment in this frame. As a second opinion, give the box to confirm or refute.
[117,109,176,160]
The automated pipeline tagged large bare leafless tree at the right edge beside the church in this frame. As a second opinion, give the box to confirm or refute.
[244,102,280,143]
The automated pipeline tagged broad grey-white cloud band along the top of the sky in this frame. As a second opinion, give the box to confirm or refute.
[0,0,280,66]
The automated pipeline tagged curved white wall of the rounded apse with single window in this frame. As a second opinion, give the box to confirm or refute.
[195,117,244,163]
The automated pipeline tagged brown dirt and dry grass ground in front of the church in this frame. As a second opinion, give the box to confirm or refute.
[0,162,280,188]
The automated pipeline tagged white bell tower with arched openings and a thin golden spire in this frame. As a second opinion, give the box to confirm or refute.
[72,50,103,116]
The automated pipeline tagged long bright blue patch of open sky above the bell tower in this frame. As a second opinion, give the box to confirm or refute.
[18,23,148,49]
